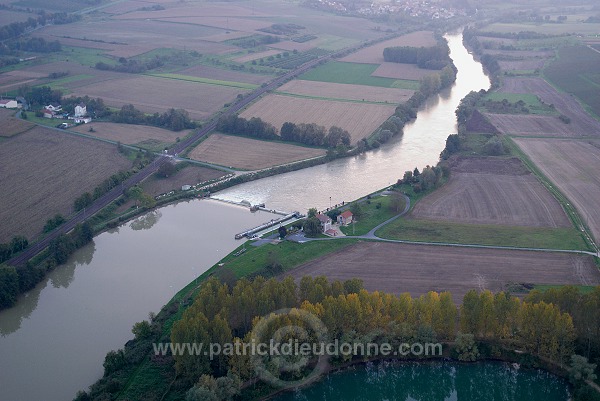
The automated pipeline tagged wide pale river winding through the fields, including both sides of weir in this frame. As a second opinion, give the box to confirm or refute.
[0,34,506,401]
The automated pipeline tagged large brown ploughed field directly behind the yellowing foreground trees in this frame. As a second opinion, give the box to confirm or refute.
[289,242,600,303]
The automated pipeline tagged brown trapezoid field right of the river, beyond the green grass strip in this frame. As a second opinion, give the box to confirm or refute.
[412,158,571,227]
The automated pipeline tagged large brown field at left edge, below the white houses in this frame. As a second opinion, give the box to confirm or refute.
[0,127,131,242]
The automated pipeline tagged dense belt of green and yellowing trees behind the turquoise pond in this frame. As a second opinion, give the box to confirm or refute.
[86,277,600,401]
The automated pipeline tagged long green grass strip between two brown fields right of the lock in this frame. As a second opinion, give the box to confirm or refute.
[377,218,588,250]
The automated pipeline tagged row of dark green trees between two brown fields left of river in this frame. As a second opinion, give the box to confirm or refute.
[217,115,351,148]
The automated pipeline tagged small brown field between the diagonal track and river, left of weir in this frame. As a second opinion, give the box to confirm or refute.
[142,163,225,196]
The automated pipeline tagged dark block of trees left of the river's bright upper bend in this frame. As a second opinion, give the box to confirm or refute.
[383,45,452,70]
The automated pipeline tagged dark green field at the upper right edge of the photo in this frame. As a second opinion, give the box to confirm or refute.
[544,46,600,116]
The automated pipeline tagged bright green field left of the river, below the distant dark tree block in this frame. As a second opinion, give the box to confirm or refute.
[299,61,398,88]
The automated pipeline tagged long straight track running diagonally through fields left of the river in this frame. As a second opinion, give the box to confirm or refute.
[8,39,376,266]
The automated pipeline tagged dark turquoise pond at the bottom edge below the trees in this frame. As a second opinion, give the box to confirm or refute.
[275,362,569,401]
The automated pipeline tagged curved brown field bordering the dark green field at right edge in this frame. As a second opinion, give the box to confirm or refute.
[500,77,600,136]
